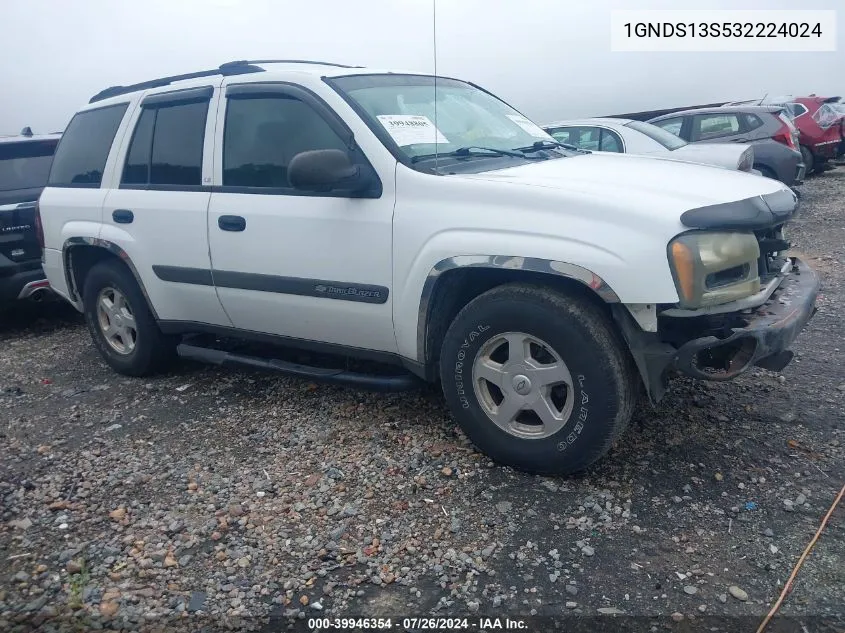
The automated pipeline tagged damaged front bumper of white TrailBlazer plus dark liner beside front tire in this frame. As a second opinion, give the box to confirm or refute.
[614,258,819,402]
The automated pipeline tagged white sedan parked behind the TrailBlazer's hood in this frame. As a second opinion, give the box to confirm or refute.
[543,117,759,173]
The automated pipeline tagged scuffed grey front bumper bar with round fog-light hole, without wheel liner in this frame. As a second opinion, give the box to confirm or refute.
[672,259,819,380]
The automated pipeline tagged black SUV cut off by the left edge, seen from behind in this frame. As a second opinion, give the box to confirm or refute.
[0,127,61,308]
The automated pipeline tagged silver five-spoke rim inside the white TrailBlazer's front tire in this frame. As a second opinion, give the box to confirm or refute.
[472,332,574,439]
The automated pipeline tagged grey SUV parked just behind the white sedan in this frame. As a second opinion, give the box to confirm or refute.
[648,106,805,186]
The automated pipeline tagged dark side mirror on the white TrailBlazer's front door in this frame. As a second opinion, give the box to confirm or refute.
[288,149,370,194]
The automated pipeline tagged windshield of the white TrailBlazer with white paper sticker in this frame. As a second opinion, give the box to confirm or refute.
[332,74,565,165]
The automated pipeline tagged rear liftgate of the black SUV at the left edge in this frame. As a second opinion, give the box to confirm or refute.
[0,140,57,267]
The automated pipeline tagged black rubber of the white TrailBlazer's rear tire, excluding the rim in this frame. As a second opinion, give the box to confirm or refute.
[82,260,176,376]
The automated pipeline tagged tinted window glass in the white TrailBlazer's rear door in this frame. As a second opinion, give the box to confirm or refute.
[121,101,208,186]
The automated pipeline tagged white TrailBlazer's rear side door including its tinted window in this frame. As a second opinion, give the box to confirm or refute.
[101,82,231,327]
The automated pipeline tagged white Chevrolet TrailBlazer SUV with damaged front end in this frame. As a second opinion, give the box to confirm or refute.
[39,60,818,473]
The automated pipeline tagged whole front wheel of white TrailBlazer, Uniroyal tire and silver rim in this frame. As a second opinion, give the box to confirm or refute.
[440,284,637,474]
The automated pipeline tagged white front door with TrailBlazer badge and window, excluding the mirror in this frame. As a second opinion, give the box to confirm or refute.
[208,83,396,352]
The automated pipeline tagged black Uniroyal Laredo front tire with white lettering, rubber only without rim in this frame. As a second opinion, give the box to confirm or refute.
[440,284,638,475]
